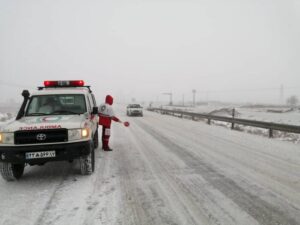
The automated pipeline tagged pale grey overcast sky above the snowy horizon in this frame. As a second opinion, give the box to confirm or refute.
[0,0,300,103]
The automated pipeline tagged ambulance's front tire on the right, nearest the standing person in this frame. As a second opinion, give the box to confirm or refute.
[79,142,95,175]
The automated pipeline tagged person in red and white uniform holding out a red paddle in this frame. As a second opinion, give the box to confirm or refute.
[99,95,129,151]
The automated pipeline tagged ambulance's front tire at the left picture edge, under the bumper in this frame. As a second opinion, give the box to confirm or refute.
[0,162,25,181]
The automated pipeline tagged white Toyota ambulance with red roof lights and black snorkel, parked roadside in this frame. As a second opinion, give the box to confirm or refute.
[0,80,99,181]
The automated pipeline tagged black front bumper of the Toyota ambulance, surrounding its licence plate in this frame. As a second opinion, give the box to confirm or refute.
[0,141,91,164]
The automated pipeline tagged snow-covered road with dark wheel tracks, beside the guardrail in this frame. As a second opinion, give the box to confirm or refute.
[0,109,300,225]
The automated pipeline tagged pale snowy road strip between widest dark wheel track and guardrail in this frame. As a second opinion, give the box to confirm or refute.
[146,114,300,213]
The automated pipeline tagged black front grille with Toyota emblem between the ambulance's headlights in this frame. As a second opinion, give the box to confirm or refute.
[15,129,68,144]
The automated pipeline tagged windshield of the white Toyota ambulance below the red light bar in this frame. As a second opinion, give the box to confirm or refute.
[25,94,86,116]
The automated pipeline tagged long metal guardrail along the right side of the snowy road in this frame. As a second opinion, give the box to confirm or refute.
[148,108,300,138]
